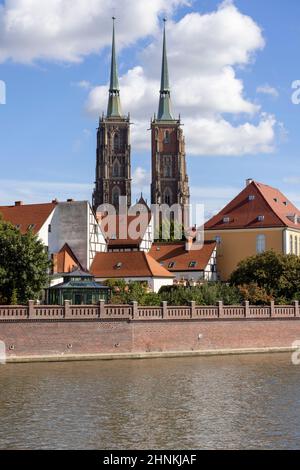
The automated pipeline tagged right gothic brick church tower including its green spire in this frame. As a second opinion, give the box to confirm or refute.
[151,20,190,215]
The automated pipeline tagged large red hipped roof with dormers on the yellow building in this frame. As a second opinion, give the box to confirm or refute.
[205,181,300,230]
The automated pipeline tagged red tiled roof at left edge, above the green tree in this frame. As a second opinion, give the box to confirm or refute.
[0,202,56,233]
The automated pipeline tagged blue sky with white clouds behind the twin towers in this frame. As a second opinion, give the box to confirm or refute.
[0,0,300,218]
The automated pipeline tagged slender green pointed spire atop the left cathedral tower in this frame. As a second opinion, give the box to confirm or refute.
[107,17,122,118]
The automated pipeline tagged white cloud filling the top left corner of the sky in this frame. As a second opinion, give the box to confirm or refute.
[0,0,186,63]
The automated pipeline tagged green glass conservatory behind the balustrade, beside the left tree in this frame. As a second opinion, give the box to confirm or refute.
[47,271,110,305]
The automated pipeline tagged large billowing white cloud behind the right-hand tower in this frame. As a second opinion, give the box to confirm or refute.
[86,1,276,156]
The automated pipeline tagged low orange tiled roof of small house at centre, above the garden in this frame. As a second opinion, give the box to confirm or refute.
[90,251,174,279]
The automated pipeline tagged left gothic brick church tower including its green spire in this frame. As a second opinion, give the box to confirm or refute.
[93,18,131,212]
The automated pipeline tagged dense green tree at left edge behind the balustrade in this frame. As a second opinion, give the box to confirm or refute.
[0,219,50,304]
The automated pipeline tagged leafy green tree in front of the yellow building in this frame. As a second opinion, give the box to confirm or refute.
[230,251,300,303]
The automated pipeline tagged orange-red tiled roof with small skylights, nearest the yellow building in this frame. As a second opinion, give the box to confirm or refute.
[150,241,217,272]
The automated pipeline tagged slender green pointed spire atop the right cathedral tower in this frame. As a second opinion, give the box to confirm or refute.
[157,19,174,121]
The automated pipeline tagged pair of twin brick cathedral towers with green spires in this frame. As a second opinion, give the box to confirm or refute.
[93,18,190,217]
